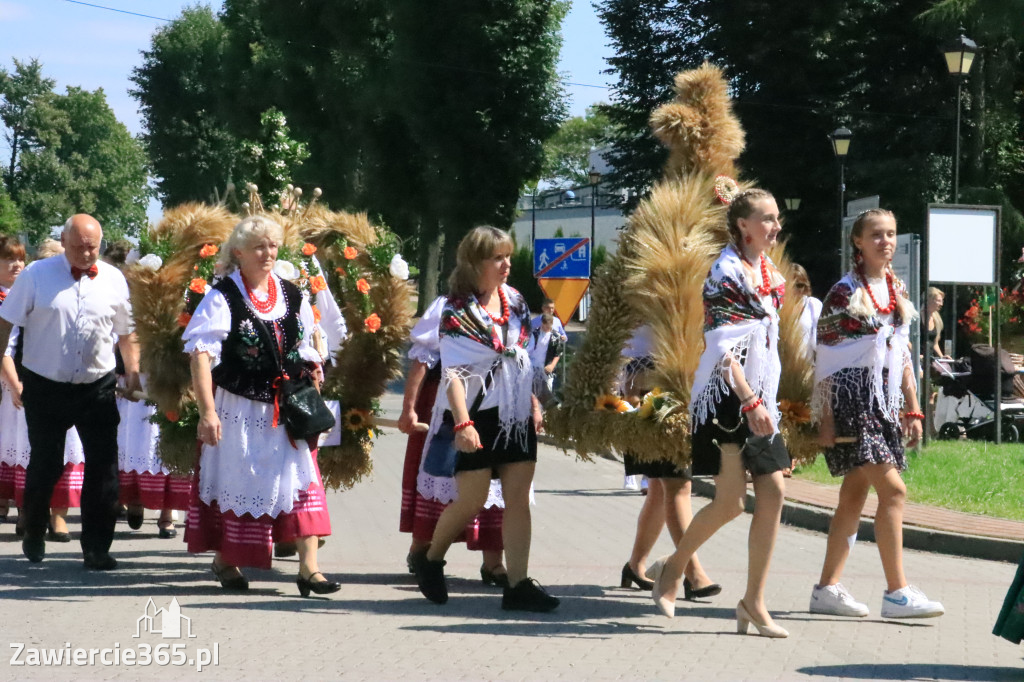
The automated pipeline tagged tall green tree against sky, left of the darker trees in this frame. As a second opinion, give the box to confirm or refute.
[130,6,237,206]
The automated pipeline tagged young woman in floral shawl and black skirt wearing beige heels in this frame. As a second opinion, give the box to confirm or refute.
[648,184,791,637]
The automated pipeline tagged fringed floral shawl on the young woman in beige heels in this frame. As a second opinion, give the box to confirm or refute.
[690,245,785,429]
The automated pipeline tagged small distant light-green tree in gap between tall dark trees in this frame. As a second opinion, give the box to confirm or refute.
[541,106,612,188]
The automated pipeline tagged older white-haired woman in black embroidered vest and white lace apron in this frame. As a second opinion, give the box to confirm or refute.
[183,216,341,596]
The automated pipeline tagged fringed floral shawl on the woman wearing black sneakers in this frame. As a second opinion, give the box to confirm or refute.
[424,285,534,452]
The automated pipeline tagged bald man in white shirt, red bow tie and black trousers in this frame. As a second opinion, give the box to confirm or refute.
[0,213,139,570]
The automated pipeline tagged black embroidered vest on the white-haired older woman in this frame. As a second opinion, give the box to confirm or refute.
[212,278,305,402]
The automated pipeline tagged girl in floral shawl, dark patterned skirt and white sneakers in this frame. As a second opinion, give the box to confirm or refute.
[810,209,944,619]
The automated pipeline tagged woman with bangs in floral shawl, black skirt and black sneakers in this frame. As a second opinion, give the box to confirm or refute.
[415,227,558,611]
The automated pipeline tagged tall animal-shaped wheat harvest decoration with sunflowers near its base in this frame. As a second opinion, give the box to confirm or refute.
[545,63,817,466]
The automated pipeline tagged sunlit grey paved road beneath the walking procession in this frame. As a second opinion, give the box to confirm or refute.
[0,430,1024,681]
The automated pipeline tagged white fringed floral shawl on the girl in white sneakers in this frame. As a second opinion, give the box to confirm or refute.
[811,272,918,422]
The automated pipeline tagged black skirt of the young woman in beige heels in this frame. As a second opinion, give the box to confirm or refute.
[690,391,793,476]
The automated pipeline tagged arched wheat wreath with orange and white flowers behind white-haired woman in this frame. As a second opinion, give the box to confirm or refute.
[125,185,412,489]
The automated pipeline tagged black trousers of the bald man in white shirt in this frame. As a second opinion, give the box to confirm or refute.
[20,368,121,552]
